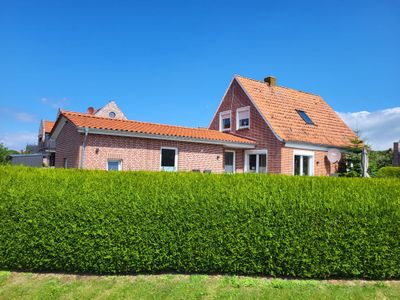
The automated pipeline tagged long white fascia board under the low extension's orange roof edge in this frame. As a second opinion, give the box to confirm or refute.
[78,127,255,149]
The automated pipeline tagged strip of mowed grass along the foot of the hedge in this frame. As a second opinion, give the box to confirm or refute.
[0,271,400,300]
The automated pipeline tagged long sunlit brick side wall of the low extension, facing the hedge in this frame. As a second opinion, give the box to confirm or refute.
[84,132,224,173]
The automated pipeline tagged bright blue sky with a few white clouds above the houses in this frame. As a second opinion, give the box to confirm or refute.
[0,0,400,149]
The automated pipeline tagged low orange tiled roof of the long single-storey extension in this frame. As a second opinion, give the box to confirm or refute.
[55,111,255,146]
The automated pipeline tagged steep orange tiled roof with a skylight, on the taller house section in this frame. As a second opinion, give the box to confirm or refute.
[235,75,356,147]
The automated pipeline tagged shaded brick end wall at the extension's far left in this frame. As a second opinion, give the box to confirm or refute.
[55,122,83,168]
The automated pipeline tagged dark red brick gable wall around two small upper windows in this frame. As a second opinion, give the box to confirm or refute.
[209,80,283,173]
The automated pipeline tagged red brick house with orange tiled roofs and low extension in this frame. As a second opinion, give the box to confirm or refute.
[51,75,356,175]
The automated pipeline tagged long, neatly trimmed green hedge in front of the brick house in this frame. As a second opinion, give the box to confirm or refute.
[0,167,400,278]
